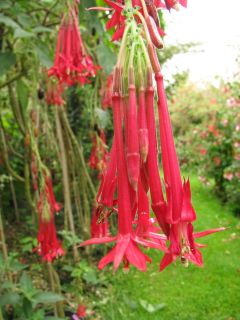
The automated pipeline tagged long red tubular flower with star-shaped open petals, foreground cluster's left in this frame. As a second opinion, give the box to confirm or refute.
[81,69,166,271]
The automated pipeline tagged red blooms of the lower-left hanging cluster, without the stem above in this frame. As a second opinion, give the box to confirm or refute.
[37,176,64,262]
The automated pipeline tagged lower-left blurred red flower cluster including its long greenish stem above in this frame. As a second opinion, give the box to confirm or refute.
[29,109,64,262]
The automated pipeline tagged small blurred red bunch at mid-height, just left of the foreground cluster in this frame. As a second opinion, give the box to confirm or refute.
[89,129,108,174]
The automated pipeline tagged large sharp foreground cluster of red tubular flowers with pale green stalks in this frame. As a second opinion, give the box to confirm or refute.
[81,0,224,271]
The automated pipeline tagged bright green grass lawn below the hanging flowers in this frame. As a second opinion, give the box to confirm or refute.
[96,177,240,320]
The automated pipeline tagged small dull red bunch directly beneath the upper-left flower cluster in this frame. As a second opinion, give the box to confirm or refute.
[45,79,65,106]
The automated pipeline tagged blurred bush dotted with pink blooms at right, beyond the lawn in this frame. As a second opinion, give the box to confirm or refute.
[170,83,240,213]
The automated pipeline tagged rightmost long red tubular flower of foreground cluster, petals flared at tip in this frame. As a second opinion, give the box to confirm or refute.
[148,35,225,270]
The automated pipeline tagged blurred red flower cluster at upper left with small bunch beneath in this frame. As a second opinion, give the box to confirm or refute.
[45,0,100,106]
